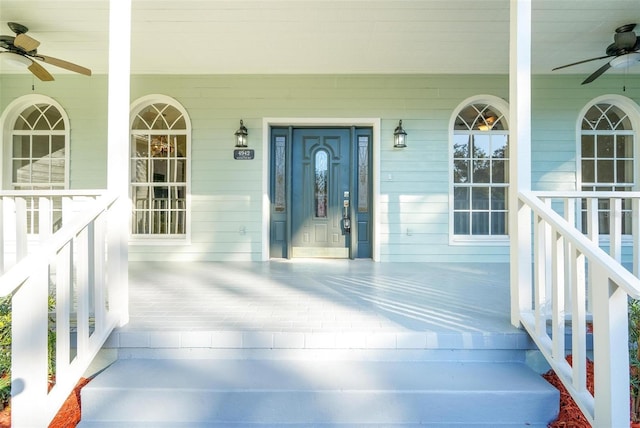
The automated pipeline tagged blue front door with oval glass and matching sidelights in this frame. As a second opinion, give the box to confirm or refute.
[270,127,372,258]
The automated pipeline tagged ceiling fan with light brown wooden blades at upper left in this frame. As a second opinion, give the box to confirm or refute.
[0,22,91,82]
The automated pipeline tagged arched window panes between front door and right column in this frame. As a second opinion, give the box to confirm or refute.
[451,100,509,239]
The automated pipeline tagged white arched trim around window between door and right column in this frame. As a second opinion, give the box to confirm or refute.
[447,94,515,247]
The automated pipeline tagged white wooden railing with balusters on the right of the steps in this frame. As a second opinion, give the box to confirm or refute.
[512,192,640,428]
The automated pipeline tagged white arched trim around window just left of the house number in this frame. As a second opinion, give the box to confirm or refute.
[127,94,192,246]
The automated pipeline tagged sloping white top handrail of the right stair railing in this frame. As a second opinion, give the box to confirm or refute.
[518,191,640,299]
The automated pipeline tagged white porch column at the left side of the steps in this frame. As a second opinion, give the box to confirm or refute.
[107,0,131,325]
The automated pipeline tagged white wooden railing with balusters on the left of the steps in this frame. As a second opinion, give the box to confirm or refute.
[0,192,124,428]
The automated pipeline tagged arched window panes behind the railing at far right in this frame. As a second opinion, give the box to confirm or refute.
[578,99,636,234]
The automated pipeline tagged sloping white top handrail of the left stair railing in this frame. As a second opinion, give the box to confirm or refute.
[0,194,117,297]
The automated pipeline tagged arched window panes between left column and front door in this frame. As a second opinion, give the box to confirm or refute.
[131,97,191,237]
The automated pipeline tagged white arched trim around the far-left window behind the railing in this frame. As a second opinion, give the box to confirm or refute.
[0,94,71,190]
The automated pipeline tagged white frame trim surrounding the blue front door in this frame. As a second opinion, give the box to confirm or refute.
[262,117,380,262]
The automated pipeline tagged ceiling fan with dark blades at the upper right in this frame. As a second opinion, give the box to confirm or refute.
[552,24,640,85]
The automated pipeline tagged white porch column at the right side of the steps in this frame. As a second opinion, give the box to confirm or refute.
[509,0,531,326]
